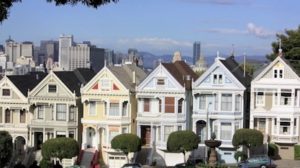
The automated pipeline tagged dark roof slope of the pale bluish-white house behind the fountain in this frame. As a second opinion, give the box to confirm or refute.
[220,56,251,87]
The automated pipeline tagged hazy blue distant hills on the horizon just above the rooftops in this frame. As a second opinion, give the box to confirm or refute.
[139,52,268,68]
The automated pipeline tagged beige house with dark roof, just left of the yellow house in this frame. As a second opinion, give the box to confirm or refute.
[28,69,94,149]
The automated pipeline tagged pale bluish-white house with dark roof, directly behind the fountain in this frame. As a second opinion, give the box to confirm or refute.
[192,56,251,163]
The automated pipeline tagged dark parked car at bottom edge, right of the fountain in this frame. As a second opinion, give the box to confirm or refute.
[238,155,277,168]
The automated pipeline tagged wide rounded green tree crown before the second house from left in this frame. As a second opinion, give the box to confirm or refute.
[42,137,79,160]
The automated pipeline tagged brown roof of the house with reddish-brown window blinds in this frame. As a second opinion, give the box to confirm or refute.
[162,61,198,89]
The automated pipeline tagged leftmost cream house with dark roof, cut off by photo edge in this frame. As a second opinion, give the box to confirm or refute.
[0,73,46,152]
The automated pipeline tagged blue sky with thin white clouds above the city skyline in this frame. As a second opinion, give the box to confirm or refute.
[0,0,300,56]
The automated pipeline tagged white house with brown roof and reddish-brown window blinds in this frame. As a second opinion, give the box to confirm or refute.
[136,61,197,151]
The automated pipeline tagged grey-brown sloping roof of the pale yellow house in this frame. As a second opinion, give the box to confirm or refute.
[107,64,147,90]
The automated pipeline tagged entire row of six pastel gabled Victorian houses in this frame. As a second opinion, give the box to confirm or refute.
[0,52,300,167]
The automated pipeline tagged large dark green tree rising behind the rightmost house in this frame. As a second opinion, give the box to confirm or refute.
[267,26,300,61]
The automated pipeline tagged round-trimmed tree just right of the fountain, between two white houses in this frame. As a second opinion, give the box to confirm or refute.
[232,128,264,156]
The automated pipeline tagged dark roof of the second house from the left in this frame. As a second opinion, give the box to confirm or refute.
[54,69,95,96]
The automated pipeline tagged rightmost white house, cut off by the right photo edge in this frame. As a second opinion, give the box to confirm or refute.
[250,56,300,159]
